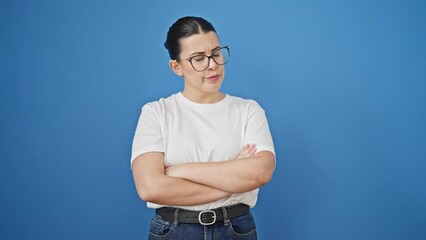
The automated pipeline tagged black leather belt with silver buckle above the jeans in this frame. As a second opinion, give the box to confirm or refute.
[155,204,250,225]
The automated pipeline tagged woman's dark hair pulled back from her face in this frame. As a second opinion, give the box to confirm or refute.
[164,17,216,60]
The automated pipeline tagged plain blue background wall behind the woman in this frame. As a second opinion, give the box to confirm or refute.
[0,0,426,240]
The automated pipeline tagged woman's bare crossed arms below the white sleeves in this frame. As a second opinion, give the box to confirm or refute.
[133,145,275,206]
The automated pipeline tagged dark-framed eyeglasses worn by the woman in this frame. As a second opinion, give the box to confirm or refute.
[177,46,230,72]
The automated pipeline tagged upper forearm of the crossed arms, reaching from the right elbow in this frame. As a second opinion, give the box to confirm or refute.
[167,152,275,193]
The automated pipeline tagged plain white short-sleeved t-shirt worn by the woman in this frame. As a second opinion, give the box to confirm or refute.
[131,92,275,210]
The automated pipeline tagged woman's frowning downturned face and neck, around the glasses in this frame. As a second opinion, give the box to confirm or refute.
[171,32,225,97]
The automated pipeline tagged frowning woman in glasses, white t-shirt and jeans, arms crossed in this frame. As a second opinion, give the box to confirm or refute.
[132,17,275,240]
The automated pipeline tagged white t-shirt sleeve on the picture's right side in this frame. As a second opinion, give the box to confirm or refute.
[245,101,275,155]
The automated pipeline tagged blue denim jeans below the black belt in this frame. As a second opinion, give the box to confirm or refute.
[148,212,257,240]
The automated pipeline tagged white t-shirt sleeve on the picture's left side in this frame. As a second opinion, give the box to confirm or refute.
[130,104,164,168]
